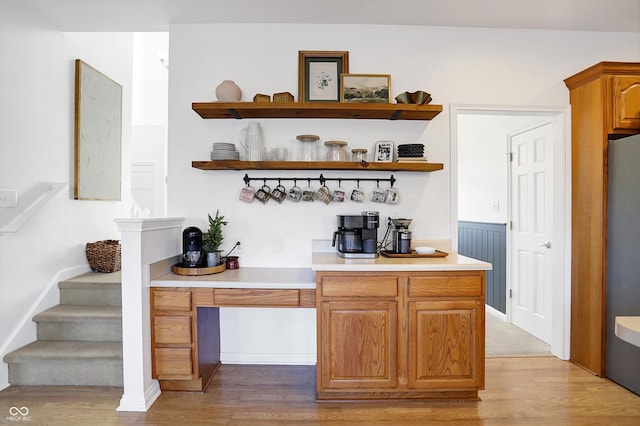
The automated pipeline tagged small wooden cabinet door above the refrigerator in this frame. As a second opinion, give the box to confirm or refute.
[612,75,640,130]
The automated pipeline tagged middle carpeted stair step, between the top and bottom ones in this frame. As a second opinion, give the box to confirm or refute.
[33,305,122,342]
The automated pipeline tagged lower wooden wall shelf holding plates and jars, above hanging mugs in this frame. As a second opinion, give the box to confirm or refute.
[191,160,444,172]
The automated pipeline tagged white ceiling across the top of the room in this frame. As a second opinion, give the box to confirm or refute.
[22,0,640,33]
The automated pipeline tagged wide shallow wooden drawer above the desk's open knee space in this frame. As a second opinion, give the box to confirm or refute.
[214,288,300,306]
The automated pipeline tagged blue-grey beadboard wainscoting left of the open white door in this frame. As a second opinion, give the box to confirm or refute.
[458,221,507,313]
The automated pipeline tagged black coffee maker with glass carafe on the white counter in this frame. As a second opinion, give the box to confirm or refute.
[331,211,380,259]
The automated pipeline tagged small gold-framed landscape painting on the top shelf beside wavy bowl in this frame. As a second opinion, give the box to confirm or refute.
[340,74,391,104]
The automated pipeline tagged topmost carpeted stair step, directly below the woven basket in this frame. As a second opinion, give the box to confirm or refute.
[58,271,122,306]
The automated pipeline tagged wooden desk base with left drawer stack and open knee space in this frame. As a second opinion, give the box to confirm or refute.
[151,287,315,392]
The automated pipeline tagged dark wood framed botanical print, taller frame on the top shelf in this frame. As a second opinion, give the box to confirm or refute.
[298,50,349,102]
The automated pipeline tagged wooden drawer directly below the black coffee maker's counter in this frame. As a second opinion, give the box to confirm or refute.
[321,275,398,297]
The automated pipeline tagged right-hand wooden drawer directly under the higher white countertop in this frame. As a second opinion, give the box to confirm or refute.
[409,275,482,297]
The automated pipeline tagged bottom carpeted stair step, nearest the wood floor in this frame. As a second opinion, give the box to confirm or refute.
[3,341,123,386]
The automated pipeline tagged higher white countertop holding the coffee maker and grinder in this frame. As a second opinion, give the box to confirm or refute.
[311,252,492,272]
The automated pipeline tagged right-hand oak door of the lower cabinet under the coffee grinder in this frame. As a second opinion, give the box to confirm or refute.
[408,300,484,389]
